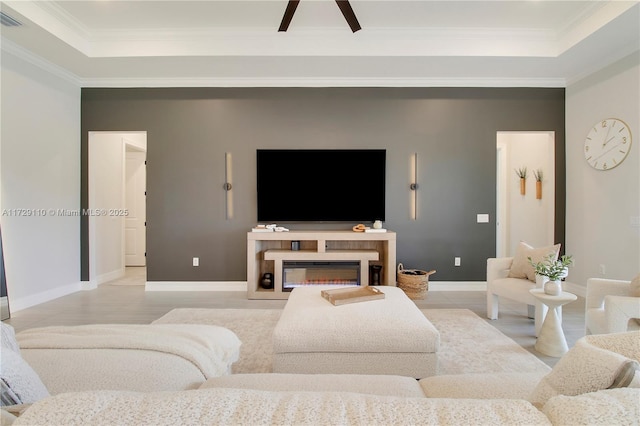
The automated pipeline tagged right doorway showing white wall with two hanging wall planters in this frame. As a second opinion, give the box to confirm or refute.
[496,131,556,257]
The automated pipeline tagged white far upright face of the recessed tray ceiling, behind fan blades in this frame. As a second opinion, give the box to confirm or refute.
[83,28,558,57]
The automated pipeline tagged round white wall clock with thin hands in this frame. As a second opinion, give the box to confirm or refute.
[584,118,631,170]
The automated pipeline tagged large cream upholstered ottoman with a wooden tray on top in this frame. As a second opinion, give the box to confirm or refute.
[273,286,440,378]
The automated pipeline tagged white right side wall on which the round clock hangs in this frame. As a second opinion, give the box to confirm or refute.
[566,52,640,285]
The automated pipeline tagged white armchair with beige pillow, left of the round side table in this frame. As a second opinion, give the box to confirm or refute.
[487,257,547,336]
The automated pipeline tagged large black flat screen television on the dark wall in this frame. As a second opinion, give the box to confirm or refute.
[257,149,386,223]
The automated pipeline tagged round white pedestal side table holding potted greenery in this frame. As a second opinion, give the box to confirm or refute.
[529,288,578,357]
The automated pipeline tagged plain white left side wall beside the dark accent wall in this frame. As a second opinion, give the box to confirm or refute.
[0,50,81,311]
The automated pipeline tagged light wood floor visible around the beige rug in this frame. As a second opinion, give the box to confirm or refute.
[6,268,584,366]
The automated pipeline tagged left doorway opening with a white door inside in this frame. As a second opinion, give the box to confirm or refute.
[86,132,147,287]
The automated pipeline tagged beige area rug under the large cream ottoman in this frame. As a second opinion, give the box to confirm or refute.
[154,309,550,374]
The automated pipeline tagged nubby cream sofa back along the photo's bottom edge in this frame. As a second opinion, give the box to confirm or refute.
[14,388,551,426]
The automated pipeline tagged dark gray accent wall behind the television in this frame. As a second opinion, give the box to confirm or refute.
[81,88,565,281]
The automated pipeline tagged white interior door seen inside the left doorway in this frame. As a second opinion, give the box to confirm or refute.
[124,151,147,266]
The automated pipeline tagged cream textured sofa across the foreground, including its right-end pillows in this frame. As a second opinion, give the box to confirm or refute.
[6,332,640,426]
